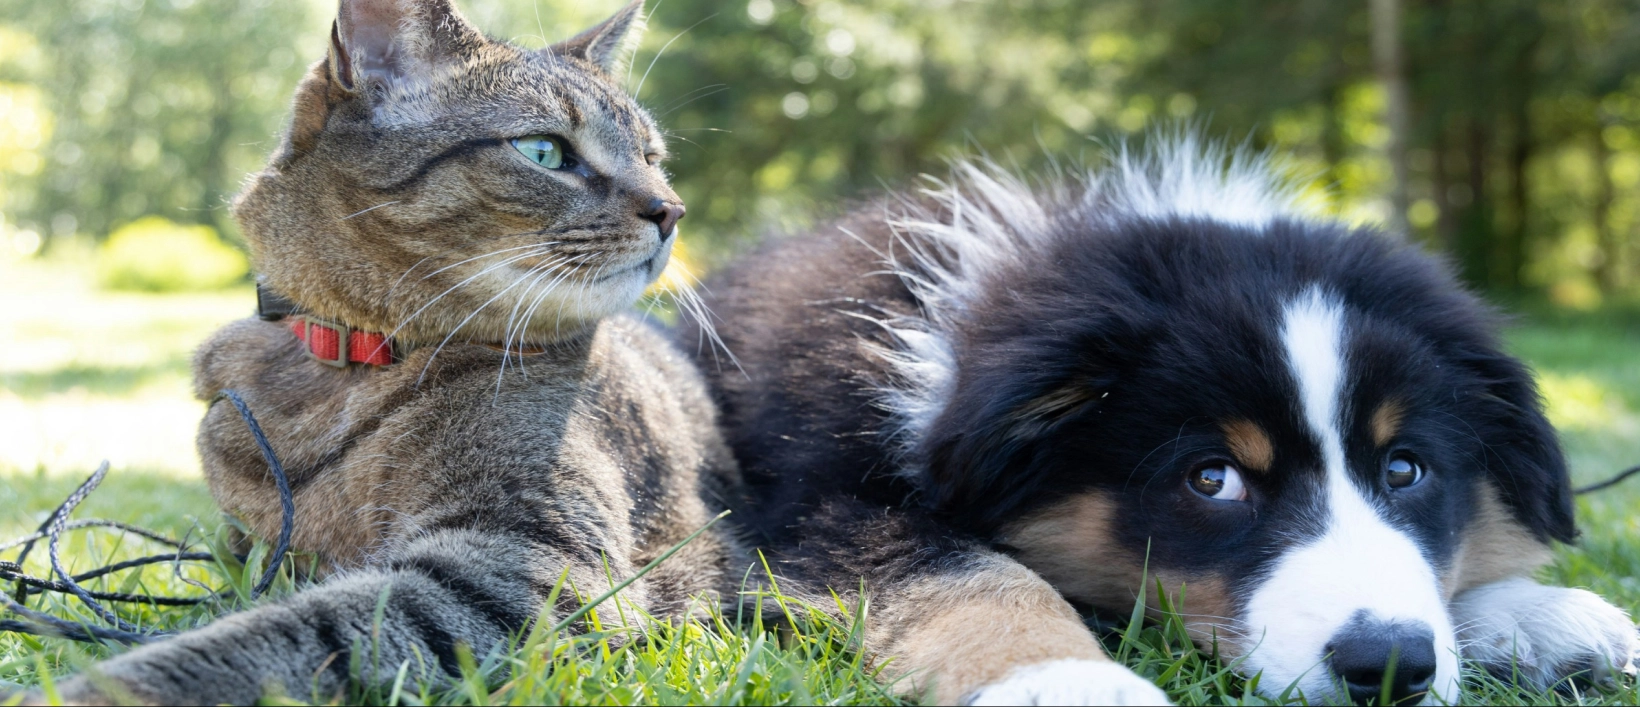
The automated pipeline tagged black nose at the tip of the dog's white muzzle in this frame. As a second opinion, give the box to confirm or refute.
[1327,612,1435,705]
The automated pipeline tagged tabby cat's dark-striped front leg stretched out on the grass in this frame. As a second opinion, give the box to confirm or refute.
[33,528,616,705]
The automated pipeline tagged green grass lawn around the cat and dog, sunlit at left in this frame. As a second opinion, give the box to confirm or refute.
[0,252,1640,705]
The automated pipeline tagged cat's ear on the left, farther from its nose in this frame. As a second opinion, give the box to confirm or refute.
[330,0,484,92]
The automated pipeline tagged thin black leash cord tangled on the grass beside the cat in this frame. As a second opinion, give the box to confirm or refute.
[0,390,297,643]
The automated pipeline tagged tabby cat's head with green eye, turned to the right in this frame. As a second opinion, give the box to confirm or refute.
[235,0,684,343]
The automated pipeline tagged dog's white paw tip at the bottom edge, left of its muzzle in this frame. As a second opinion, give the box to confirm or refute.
[964,659,1168,705]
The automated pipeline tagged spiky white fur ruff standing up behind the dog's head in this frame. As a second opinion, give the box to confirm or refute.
[872,131,1317,465]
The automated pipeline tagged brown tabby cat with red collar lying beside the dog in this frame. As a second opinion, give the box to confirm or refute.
[19,0,746,704]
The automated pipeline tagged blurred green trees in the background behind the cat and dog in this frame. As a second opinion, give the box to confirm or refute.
[0,0,1640,301]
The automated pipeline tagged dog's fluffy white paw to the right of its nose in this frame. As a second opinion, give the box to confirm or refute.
[1451,579,1640,689]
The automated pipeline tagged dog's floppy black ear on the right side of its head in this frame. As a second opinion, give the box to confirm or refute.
[1460,348,1578,543]
